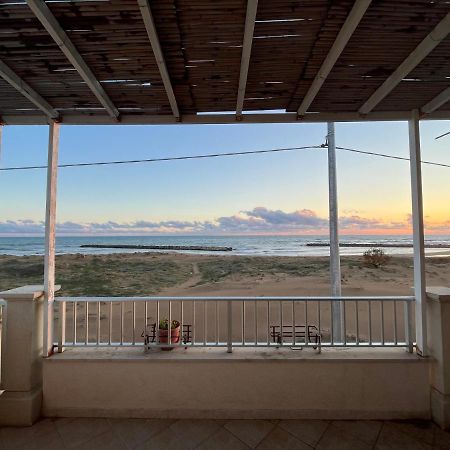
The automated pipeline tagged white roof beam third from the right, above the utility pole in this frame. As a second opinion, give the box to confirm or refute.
[297,0,372,116]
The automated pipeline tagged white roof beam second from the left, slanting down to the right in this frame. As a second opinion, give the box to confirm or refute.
[27,0,119,118]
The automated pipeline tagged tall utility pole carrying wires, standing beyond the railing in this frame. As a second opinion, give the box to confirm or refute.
[327,122,345,342]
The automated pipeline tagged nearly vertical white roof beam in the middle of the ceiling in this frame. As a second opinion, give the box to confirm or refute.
[236,0,258,117]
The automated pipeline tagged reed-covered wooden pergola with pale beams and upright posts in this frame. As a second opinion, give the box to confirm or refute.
[0,0,450,353]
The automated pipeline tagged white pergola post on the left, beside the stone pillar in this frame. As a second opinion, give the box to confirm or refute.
[43,122,59,356]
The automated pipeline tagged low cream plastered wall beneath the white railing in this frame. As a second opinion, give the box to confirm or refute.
[43,349,430,419]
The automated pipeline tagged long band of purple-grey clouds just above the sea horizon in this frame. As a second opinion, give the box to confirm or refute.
[0,206,450,236]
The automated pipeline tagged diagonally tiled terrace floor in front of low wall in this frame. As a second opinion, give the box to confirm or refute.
[0,419,450,450]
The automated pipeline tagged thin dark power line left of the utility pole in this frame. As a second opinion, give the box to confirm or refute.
[0,145,321,171]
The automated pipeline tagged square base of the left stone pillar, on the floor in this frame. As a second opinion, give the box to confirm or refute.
[0,387,42,426]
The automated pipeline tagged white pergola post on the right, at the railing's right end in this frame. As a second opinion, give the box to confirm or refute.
[409,110,427,356]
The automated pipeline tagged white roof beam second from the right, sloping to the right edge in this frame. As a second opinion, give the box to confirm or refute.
[359,13,450,114]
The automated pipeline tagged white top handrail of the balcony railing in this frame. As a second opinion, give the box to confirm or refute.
[55,295,415,303]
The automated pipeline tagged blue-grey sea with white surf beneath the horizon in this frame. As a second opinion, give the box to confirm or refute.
[0,235,450,256]
